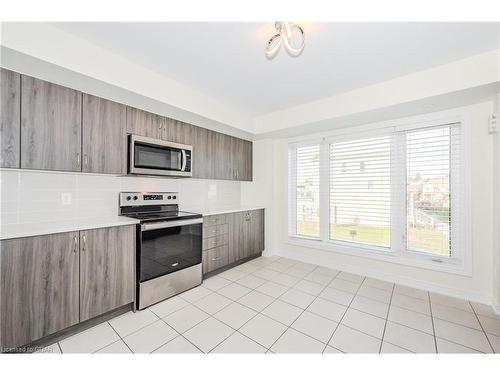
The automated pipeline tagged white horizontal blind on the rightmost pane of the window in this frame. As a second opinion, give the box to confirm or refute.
[406,125,460,257]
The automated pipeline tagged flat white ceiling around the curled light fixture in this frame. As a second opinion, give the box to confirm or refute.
[52,22,500,116]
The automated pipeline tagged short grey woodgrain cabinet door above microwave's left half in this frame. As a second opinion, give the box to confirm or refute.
[127,107,166,139]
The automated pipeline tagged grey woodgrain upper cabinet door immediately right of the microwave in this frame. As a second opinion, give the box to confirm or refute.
[192,126,216,179]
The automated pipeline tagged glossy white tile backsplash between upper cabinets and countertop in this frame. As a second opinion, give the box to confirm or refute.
[0,169,241,225]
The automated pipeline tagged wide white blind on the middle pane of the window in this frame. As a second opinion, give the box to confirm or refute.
[329,136,391,247]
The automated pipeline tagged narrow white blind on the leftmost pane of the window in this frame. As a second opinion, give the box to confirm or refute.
[292,144,320,237]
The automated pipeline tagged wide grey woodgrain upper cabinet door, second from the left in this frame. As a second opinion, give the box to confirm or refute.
[21,76,82,171]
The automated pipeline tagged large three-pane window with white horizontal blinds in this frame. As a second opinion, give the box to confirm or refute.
[288,121,465,269]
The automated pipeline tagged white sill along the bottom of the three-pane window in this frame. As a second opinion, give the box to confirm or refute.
[285,236,472,277]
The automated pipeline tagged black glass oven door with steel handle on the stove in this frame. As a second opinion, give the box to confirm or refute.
[137,218,203,283]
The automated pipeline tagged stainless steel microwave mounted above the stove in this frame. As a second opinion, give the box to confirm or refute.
[128,135,193,177]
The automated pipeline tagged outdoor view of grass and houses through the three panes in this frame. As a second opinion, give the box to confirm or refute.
[295,126,458,256]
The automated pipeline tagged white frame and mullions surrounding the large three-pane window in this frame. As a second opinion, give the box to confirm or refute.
[285,108,472,276]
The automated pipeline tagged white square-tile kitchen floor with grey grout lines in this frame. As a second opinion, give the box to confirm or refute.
[41,257,500,353]
